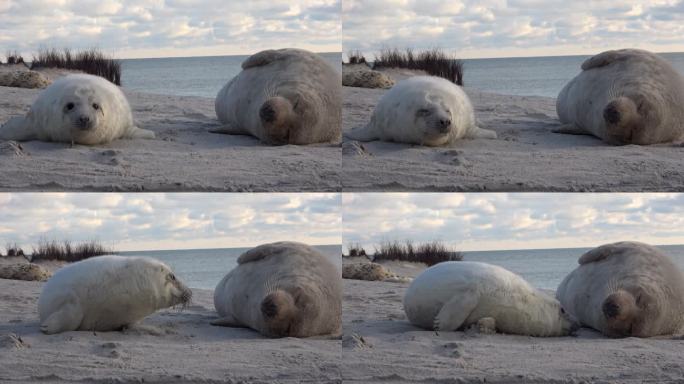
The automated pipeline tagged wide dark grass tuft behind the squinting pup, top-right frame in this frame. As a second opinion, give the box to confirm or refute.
[373,48,463,86]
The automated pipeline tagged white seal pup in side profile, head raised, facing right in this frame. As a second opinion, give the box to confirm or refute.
[38,256,192,334]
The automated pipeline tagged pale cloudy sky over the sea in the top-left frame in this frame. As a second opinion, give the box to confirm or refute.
[0,0,341,58]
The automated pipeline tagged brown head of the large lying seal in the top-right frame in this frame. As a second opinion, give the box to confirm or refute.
[603,95,661,145]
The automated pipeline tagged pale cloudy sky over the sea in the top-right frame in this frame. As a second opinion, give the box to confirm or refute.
[342,0,684,58]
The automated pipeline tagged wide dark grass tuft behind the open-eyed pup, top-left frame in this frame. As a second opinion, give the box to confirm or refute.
[31,48,121,85]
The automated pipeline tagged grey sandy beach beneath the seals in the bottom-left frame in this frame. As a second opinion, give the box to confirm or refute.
[0,258,341,384]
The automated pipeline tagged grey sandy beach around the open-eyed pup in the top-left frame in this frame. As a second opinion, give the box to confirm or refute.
[0,87,341,192]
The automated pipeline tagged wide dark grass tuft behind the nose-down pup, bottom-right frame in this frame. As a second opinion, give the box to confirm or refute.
[373,240,463,266]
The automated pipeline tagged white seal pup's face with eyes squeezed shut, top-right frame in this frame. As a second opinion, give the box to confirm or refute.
[413,97,456,146]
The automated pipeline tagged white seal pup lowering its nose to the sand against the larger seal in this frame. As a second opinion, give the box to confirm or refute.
[404,261,578,336]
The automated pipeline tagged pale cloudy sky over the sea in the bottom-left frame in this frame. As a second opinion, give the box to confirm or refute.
[0,193,341,251]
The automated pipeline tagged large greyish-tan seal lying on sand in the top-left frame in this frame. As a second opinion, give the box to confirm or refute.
[212,49,342,145]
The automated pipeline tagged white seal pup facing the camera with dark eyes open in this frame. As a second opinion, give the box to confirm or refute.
[0,74,154,145]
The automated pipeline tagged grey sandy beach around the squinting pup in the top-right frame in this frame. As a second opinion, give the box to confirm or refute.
[342,78,684,192]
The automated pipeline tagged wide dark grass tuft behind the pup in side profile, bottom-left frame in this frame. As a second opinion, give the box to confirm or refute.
[31,240,115,262]
